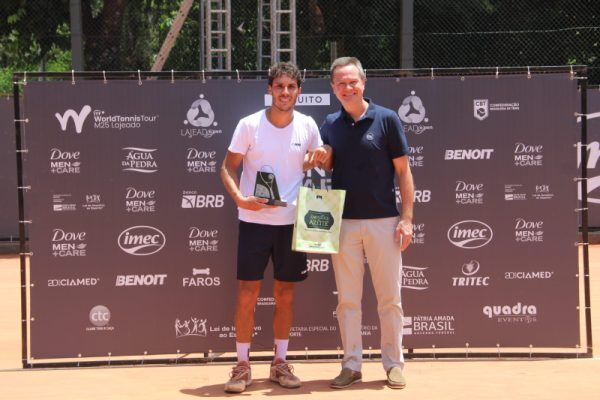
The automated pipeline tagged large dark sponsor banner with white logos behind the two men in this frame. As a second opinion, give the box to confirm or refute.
[24,75,580,359]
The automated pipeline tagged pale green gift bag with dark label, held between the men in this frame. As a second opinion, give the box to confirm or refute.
[292,186,346,254]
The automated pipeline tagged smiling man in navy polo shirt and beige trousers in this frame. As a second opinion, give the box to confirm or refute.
[321,57,414,389]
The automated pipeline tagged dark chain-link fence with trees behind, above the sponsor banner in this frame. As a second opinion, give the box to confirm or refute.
[0,0,600,92]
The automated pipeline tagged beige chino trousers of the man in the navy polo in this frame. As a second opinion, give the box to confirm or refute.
[332,217,404,371]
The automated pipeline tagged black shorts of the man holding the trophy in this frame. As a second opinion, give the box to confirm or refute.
[237,221,308,282]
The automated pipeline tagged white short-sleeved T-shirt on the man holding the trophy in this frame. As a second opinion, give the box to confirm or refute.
[228,110,323,225]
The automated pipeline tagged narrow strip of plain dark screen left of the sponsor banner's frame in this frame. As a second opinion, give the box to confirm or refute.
[0,96,19,240]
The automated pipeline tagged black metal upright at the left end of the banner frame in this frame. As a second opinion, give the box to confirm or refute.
[13,79,29,368]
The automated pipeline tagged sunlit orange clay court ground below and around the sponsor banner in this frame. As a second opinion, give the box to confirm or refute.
[0,245,600,400]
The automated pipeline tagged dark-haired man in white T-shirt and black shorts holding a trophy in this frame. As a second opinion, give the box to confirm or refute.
[221,62,331,393]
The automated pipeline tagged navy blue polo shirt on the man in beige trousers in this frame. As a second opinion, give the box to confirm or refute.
[321,98,408,219]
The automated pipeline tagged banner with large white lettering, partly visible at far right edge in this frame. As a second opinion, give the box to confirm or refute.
[577,88,600,228]
